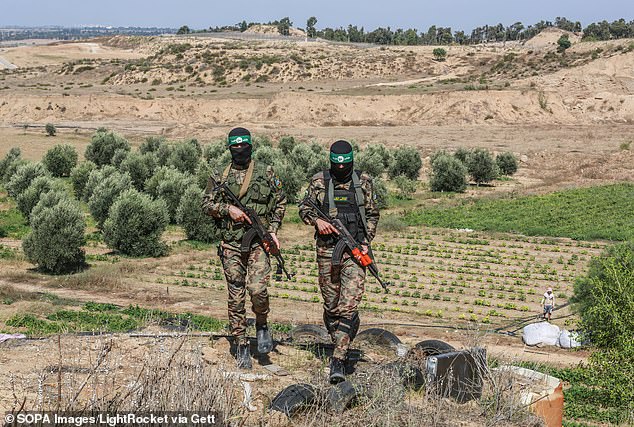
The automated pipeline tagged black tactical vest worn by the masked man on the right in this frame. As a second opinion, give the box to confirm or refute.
[318,170,367,244]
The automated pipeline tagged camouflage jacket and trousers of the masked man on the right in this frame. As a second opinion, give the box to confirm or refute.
[299,172,379,359]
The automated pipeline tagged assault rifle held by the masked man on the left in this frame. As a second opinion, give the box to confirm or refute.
[211,176,293,280]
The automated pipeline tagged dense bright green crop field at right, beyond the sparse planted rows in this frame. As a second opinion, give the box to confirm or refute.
[405,184,634,240]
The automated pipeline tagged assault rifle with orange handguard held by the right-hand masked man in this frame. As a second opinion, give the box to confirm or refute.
[300,197,391,293]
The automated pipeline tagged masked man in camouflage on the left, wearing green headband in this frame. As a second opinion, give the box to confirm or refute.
[203,128,286,369]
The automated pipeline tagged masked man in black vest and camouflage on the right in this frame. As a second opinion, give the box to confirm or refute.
[299,141,379,383]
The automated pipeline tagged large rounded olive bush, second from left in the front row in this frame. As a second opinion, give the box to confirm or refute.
[103,189,169,256]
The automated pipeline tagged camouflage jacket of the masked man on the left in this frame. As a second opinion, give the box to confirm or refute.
[202,163,286,247]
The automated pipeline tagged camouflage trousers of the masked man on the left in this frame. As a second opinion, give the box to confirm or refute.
[219,245,271,345]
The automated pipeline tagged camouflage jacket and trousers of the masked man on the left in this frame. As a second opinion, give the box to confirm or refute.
[203,160,286,345]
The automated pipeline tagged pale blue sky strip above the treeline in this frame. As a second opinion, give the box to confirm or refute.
[0,0,634,31]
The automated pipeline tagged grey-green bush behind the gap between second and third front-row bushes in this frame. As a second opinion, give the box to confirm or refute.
[145,166,195,222]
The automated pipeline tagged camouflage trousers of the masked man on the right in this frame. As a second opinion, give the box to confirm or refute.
[317,247,365,359]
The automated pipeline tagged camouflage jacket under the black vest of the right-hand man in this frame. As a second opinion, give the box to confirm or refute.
[299,171,380,244]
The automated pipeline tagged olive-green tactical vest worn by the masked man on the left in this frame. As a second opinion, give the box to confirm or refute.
[222,160,275,243]
